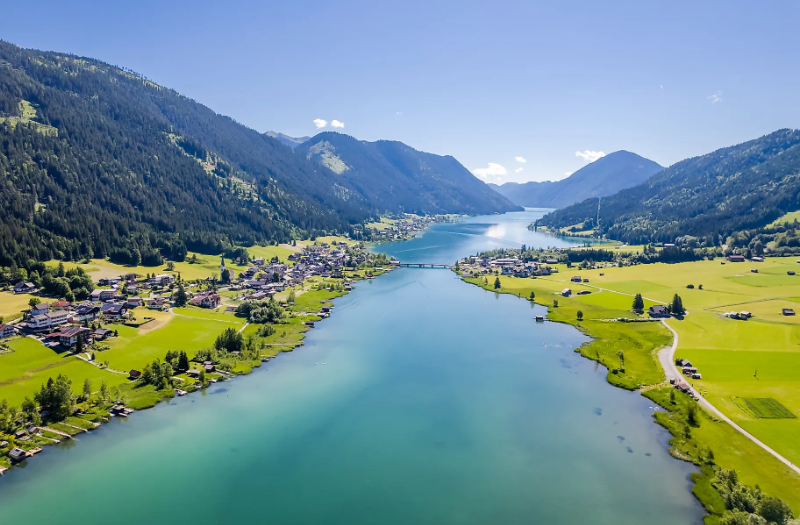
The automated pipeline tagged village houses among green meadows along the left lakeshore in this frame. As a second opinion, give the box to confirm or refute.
[0,239,398,475]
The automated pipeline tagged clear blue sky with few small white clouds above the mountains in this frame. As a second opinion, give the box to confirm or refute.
[0,0,800,182]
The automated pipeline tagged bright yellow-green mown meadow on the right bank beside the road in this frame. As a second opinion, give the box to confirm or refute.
[478,258,800,509]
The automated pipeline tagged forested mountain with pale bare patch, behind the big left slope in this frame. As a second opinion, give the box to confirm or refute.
[296,131,521,214]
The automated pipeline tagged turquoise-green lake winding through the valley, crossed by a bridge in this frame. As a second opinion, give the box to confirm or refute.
[0,208,701,525]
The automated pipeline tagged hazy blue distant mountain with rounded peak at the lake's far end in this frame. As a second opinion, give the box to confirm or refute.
[492,151,664,208]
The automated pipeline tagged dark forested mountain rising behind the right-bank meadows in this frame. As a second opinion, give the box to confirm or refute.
[538,129,800,246]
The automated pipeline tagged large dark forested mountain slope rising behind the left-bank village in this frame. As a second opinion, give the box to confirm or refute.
[0,41,510,267]
